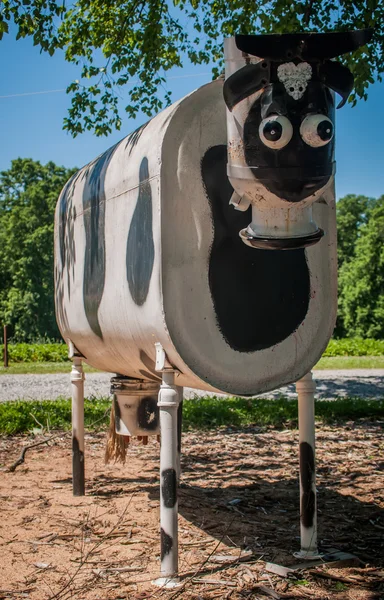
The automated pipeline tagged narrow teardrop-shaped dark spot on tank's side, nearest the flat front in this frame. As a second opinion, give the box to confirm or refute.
[126,158,155,306]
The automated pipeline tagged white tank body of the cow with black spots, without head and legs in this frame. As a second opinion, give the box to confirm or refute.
[55,80,337,395]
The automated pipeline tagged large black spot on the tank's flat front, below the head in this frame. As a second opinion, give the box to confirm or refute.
[202,146,310,352]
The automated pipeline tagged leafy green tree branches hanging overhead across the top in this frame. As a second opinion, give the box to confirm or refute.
[0,0,384,136]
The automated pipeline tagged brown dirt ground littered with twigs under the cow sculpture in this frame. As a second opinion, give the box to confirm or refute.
[0,422,384,600]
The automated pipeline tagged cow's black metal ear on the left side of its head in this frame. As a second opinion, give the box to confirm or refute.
[223,61,270,110]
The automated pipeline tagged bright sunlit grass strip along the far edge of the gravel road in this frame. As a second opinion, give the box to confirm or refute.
[0,356,384,375]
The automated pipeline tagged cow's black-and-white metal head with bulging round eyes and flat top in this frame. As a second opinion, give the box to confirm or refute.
[224,30,372,249]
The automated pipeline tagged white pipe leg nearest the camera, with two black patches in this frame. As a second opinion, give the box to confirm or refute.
[155,369,180,587]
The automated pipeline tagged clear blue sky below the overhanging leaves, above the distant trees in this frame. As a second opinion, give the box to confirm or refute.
[0,34,384,198]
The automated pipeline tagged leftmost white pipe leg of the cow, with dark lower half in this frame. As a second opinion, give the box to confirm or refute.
[71,357,85,496]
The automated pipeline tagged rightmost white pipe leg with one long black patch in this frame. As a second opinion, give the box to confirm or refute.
[295,372,319,559]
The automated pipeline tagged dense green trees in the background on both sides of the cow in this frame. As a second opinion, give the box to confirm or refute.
[0,158,384,342]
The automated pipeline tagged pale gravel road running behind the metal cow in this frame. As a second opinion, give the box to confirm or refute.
[0,369,384,402]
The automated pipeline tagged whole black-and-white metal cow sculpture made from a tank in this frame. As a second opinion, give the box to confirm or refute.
[55,31,371,578]
